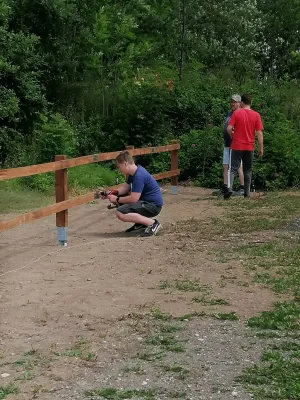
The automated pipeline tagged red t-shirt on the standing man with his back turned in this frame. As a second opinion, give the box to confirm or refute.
[228,108,264,150]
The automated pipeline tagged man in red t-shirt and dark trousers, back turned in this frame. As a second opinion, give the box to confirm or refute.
[224,94,264,199]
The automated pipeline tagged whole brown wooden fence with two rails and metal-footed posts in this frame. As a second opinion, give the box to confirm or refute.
[0,140,180,246]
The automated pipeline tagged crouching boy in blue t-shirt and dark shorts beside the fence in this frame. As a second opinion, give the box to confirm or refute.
[108,150,163,236]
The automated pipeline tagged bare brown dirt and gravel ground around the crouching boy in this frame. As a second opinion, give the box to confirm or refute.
[0,187,278,400]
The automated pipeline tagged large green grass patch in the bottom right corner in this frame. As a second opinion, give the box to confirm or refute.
[238,301,300,400]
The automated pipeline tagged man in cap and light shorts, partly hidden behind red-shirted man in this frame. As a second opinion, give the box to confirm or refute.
[213,94,244,195]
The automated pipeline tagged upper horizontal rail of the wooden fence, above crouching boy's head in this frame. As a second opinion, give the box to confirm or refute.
[0,143,180,181]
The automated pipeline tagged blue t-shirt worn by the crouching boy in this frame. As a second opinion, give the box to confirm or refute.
[127,165,164,207]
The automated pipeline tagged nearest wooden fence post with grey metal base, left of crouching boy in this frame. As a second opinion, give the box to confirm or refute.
[55,155,68,246]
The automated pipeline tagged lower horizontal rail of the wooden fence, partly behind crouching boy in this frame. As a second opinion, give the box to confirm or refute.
[0,169,180,232]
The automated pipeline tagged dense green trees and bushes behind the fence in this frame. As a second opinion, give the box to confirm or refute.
[0,0,300,188]
